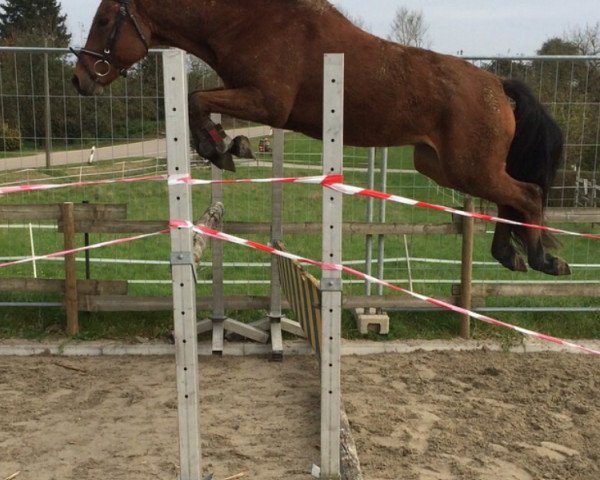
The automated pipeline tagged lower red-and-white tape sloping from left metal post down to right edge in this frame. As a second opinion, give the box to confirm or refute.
[170,220,600,355]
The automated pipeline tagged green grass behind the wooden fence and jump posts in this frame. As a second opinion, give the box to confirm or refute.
[0,134,600,342]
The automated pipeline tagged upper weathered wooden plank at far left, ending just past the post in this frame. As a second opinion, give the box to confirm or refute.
[0,203,127,221]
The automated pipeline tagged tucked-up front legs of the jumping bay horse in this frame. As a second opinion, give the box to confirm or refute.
[188,88,290,171]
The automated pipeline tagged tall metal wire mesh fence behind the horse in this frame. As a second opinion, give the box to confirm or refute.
[0,48,600,312]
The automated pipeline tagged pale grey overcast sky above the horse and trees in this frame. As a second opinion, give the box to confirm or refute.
[59,0,600,56]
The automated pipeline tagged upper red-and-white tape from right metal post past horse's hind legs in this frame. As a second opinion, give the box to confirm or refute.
[323,181,600,240]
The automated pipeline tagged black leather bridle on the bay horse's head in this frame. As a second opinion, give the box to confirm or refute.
[69,0,150,78]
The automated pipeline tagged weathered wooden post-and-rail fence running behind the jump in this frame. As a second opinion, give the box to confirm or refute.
[0,203,600,337]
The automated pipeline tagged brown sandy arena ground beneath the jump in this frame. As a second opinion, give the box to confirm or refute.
[0,350,600,480]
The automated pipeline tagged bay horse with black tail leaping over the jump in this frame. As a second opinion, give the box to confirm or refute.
[73,0,570,275]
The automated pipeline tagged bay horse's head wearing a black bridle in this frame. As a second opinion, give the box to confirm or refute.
[71,0,151,95]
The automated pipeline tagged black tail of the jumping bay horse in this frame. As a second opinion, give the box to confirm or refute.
[503,80,564,247]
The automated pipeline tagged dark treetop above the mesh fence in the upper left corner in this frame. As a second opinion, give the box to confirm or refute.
[0,0,71,47]
